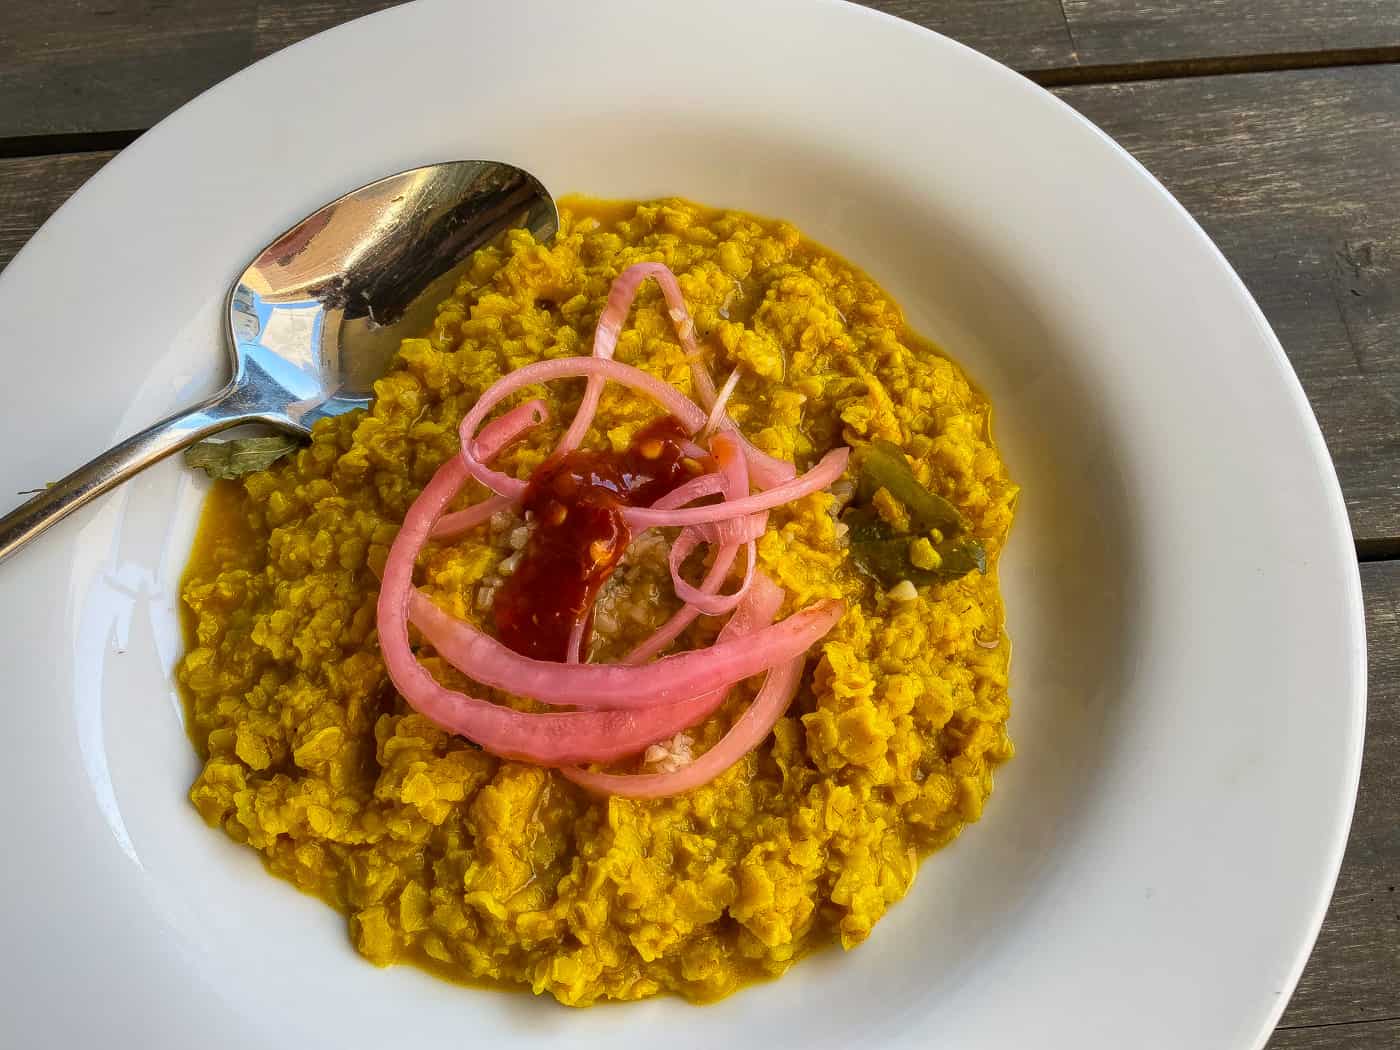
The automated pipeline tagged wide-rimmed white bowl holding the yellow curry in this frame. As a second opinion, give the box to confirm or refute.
[0,0,1365,1050]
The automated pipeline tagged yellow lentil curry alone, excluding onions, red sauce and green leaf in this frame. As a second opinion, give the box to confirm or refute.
[179,199,1016,1005]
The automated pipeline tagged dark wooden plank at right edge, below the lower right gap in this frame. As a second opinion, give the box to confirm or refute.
[1270,561,1400,1050]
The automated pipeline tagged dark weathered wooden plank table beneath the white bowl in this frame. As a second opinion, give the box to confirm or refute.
[0,0,1400,1050]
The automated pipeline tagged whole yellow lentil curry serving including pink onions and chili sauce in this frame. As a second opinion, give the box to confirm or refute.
[179,197,1016,1007]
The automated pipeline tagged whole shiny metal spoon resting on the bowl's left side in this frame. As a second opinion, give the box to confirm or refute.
[0,161,559,560]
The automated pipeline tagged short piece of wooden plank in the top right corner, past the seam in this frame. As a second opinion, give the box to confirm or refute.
[1064,0,1400,64]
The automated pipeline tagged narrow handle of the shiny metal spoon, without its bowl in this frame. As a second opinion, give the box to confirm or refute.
[0,388,263,561]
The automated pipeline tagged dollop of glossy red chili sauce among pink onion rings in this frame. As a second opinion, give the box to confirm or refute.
[496,416,697,661]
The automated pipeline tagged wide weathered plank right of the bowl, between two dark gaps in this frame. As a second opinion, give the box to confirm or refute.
[1057,65,1400,543]
